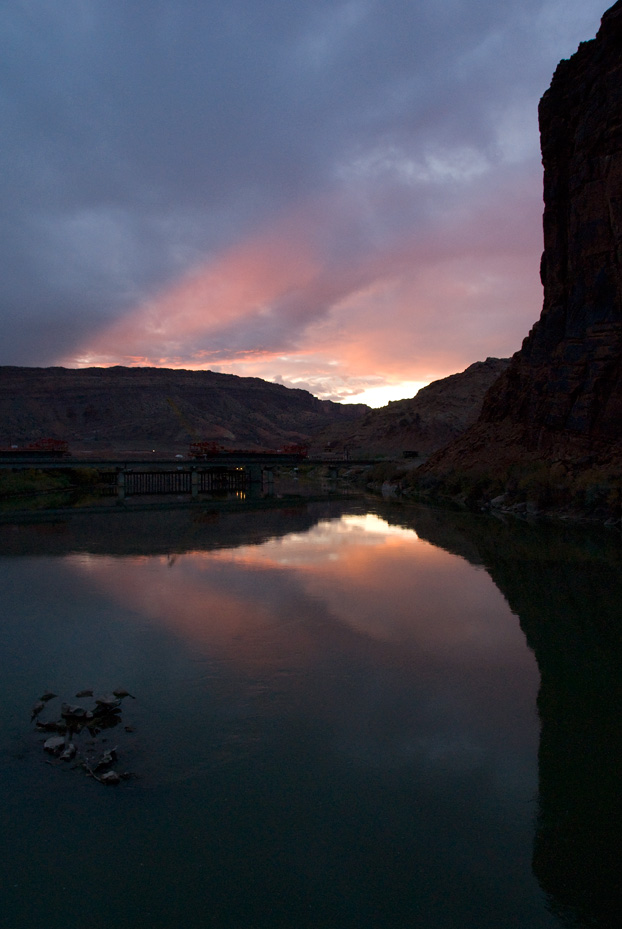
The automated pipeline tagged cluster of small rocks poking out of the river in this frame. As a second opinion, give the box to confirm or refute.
[30,687,134,785]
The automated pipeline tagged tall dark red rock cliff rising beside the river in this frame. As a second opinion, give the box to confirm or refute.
[419,0,622,521]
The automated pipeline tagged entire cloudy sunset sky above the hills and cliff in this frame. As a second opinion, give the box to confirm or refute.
[0,0,611,406]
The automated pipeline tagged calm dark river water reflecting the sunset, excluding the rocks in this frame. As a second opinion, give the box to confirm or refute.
[0,503,622,929]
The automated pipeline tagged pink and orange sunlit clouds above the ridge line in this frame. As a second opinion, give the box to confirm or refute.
[63,170,541,399]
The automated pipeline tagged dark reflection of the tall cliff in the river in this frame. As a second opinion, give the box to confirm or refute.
[393,510,622,929]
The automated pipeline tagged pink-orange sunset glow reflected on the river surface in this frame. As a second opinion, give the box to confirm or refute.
[68,514,528,656]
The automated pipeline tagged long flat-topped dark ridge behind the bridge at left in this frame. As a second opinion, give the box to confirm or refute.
[0,367,369,453]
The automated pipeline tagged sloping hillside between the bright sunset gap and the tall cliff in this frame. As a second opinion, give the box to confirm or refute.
[314,358,509,456]
